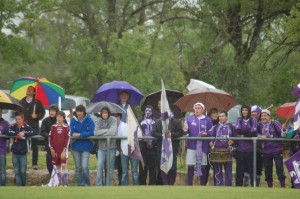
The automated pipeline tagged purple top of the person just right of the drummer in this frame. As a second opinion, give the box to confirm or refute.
[235,117,257,152]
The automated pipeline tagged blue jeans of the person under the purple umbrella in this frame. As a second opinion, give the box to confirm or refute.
[121,154,139,185]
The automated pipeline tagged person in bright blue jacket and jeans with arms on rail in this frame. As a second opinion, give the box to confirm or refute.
[70,105,95,186]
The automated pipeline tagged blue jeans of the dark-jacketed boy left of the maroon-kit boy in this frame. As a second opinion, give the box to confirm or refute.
[12,154,27,186]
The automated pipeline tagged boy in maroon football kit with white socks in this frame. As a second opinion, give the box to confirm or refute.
[49,111,70,186]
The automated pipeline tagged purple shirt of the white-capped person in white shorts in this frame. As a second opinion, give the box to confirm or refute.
[183,114,212,153]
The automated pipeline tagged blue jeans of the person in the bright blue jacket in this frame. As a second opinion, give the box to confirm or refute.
[72,150,91,186]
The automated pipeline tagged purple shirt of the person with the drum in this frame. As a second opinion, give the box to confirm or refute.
[209,122,236,148]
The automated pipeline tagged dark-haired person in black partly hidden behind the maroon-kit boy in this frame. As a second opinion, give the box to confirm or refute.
[41,105,58,176]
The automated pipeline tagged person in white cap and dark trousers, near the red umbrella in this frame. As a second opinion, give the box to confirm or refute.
[258,109,285,188]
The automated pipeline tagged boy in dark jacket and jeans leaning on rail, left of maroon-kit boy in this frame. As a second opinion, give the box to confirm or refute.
[7,112,36,186]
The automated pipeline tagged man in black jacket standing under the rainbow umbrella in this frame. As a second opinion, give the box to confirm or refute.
[20,86,45,170]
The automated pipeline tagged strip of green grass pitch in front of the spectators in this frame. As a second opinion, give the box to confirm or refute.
[0,186,299,199]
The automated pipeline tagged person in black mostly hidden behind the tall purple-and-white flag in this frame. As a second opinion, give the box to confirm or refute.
[152,117,183,185]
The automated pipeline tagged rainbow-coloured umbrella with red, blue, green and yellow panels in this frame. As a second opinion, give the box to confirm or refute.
[10,77,65,106]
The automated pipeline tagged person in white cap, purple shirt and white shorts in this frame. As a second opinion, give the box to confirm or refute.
[183,102,212,186]
